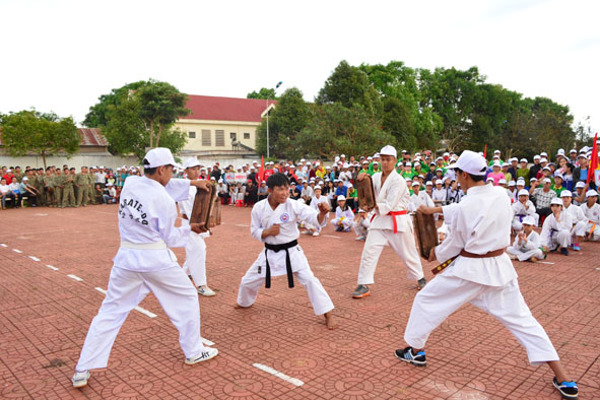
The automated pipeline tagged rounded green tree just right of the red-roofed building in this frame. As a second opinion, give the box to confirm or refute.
[256,87,309,160]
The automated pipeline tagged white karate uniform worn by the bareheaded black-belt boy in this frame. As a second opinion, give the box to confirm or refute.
[238,198,333,315]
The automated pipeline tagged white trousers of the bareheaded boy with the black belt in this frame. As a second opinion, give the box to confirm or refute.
[238,246,334,315]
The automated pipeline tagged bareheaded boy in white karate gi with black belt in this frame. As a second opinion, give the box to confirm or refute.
[236,173,335,329]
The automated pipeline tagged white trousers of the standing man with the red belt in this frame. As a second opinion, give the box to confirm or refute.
[358,228,424,285]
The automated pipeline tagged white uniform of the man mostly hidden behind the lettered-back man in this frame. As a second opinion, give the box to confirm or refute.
[179,186,210,287]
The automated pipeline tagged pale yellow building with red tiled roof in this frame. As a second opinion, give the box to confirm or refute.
[176,95,277,156]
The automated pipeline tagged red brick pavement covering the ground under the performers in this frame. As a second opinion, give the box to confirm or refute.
[0,206,600,400]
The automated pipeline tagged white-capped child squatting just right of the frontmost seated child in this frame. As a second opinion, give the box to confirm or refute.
[541,197,573,256]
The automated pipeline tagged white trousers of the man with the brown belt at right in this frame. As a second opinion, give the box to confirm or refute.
[404,274,559,365]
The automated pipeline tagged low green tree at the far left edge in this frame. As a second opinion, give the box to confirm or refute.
[1,110,81,167]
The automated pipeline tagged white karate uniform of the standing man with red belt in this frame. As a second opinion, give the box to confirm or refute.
[358,170,424,285]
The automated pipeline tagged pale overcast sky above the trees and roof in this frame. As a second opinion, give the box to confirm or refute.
[0,0,600,131]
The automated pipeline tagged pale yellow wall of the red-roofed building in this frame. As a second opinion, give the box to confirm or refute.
[175,119,260,151]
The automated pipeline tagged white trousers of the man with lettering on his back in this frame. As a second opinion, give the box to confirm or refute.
[76,266,204,371]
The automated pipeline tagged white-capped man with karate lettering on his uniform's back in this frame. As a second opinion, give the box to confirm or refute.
[72,148,218,387]
